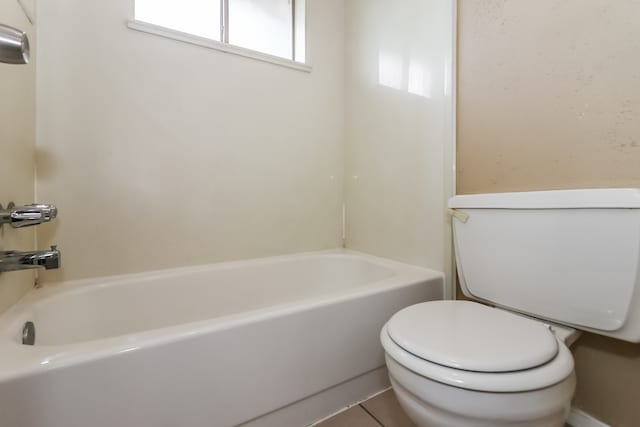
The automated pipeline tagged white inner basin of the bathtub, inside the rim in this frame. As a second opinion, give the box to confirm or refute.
[6,254,397,346]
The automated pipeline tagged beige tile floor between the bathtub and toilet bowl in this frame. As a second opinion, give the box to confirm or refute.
[316,390,415,427]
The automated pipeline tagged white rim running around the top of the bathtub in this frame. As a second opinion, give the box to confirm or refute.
[0,249,444,382]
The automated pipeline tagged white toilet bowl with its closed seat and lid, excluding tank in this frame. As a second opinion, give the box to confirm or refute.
[380,301,576,427]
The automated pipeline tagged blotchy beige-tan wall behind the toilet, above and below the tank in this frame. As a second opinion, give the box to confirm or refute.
[458,0,640,426]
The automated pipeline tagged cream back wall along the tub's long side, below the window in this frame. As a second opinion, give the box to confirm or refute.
[37,0,344,281]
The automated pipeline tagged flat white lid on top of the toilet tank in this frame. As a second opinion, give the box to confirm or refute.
[449,188,640,209]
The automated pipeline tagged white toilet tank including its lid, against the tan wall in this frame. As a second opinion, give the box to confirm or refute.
[449,189,640,342]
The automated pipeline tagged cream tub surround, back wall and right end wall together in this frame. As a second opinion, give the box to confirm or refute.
[36,0,453,290]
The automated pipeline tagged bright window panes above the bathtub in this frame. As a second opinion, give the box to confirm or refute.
[135,0,306,63]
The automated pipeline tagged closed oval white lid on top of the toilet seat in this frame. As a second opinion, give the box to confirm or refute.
[387,301,558,372]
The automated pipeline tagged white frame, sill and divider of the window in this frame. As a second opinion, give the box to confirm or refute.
[126,0,312,73]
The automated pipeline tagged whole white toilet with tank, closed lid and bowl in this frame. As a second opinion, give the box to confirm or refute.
[381,189,640,427]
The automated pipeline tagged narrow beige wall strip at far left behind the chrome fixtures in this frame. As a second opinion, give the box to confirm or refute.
[0,1,35,312]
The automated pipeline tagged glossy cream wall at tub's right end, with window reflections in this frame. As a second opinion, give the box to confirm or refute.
[345,0,453,290]
